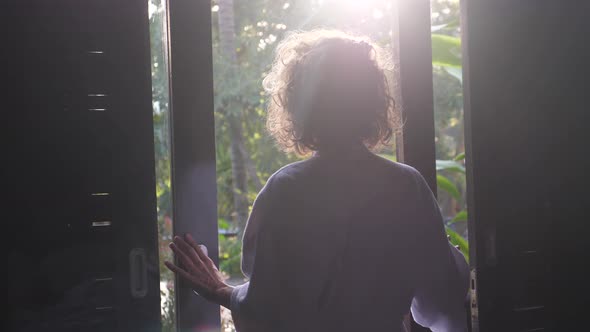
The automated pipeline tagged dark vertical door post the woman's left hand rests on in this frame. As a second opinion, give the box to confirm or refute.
[168,0,220,331]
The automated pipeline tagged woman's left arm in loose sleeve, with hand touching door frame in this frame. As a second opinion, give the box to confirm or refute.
[165,174,288,332]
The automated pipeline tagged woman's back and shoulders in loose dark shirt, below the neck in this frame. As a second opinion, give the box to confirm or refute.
[232,145,466,331]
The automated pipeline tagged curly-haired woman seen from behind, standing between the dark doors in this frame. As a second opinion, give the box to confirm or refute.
[166,30,468,332]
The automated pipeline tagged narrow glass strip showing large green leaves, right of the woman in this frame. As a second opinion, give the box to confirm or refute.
[431,0,469,257]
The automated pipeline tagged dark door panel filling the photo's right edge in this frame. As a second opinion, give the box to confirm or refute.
[462,0,590,331]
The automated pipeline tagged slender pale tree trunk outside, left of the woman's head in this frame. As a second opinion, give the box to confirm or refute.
[218,0,249,231]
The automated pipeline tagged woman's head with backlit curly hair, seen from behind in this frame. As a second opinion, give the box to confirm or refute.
[263,30,399,154]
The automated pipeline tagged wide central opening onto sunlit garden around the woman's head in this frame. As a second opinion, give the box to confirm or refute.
[211,0,395,331]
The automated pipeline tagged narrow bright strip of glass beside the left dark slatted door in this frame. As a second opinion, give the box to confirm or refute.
[148,0,176,332]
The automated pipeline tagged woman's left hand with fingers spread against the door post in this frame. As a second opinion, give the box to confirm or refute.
[164,234,233,308]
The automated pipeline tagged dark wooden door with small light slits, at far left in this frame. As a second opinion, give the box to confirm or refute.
[1,0,160,331]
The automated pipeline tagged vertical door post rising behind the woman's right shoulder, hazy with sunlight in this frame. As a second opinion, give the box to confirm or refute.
[395,0,437,332]
